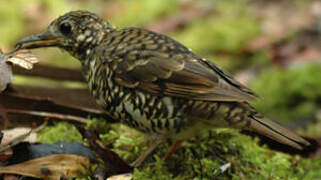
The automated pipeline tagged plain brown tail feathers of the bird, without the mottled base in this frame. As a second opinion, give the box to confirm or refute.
[249,116,310,150]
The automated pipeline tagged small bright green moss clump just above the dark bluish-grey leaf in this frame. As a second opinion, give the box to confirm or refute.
[37,122,82,143]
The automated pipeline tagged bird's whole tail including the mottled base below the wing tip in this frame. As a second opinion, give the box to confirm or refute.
[232,104,310,150]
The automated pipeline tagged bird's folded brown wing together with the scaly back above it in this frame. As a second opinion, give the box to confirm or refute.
[98,28,257,101]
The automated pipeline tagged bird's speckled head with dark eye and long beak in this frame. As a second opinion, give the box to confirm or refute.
[16,11,114,57]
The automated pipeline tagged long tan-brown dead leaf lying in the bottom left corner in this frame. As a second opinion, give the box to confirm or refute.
[0,154,92,179]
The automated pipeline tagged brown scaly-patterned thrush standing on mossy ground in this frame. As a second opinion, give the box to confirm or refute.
[16,10,309,167]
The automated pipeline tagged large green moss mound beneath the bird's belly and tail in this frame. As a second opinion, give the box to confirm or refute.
[129,130,321,180]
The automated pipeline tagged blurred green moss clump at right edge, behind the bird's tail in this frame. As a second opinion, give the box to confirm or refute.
[251,65,321,125]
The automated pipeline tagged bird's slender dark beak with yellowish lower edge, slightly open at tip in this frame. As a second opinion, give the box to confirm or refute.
[16,30,63,49]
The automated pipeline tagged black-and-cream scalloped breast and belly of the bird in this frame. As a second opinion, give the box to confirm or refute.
[83,57,183,133]
